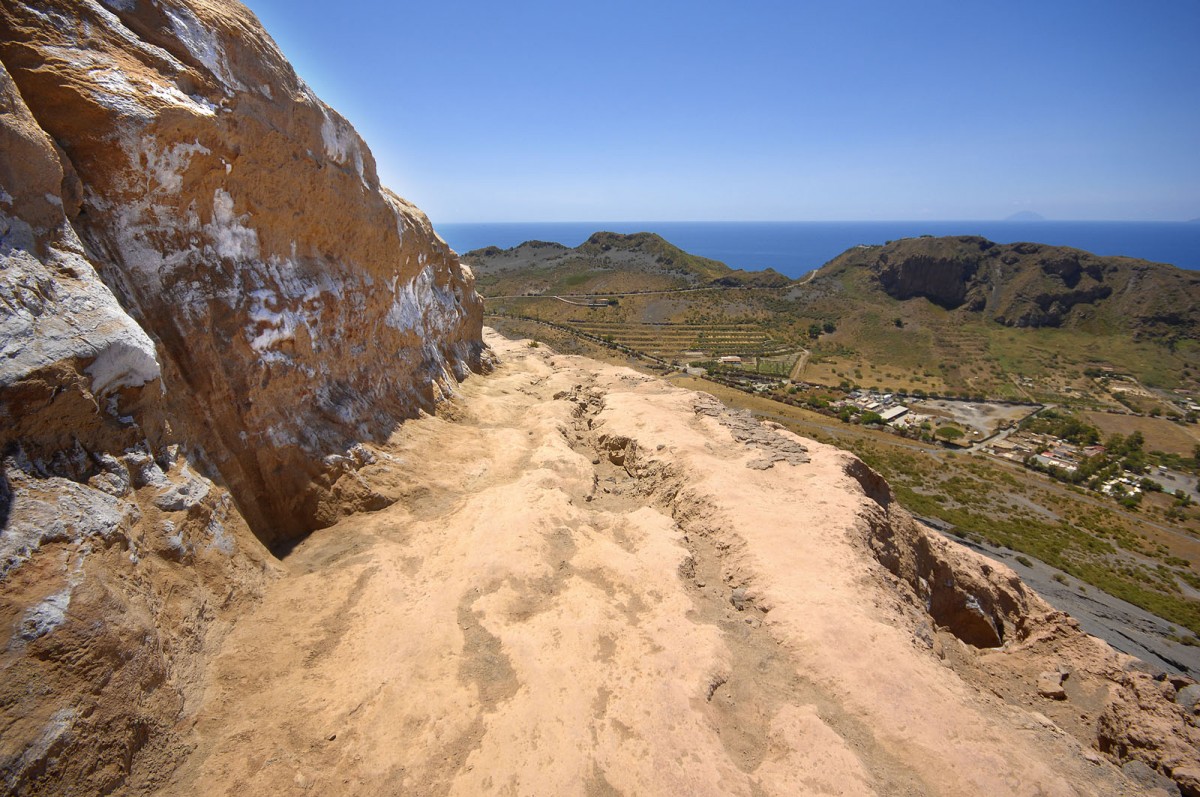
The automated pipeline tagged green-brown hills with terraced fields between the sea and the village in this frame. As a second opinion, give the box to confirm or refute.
[464,233,1200,405]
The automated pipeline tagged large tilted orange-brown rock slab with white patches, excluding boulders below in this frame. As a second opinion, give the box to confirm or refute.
[0,0,482,544]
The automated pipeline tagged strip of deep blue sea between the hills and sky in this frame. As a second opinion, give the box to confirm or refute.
[436,221,1200,277]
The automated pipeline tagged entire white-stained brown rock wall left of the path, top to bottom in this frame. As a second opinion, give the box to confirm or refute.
[0,0,488,793]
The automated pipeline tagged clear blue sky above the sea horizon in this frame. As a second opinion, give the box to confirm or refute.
[247,0,1200,222]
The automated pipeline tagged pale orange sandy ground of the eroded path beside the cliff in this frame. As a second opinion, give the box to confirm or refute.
[167,335,1141,797]
